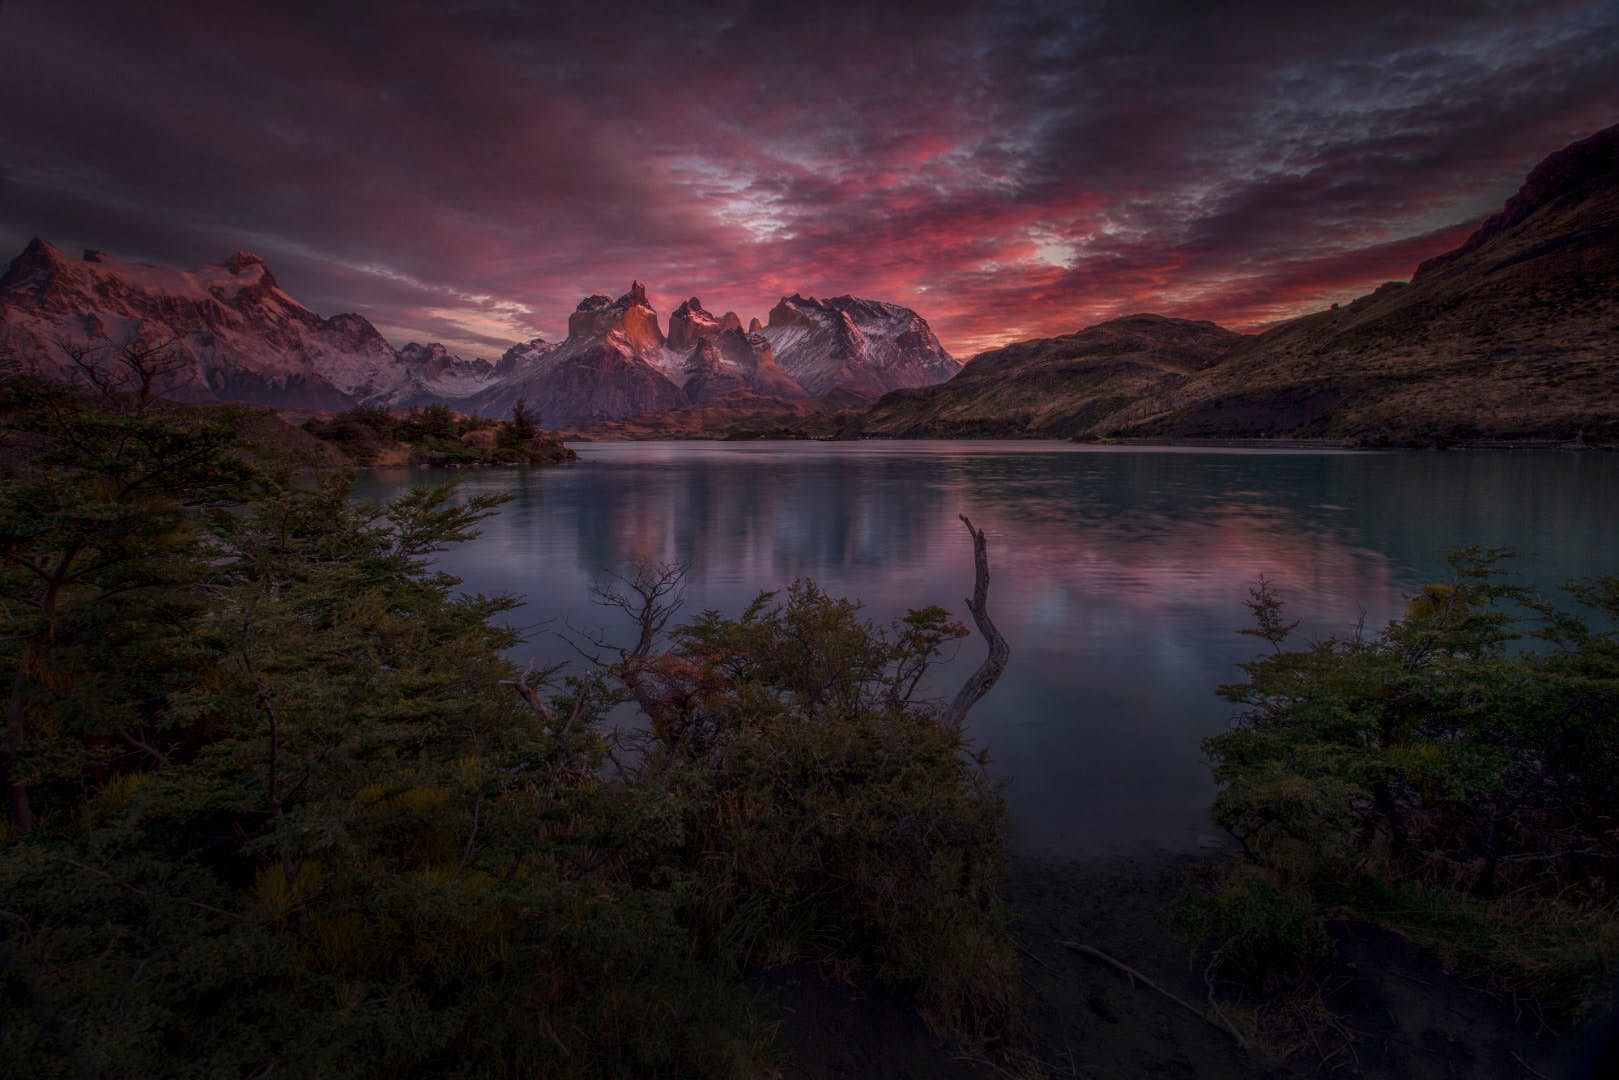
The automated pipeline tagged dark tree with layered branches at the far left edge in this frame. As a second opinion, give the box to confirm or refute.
[0,375,253,834]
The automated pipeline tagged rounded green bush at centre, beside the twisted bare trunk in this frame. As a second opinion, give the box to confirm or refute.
[620,581,1017,1038]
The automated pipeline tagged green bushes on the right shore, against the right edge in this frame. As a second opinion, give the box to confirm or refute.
[1206,551,1619,1014]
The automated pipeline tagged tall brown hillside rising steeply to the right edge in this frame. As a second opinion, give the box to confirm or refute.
[1098,125,1619,442]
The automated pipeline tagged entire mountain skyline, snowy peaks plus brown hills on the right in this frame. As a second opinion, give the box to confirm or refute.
[0,125,1619,442]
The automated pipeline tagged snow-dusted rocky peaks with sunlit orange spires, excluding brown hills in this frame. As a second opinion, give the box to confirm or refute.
[0,240,958,426]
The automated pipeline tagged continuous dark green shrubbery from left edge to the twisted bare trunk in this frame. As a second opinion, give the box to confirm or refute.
[0,382,1012,1077]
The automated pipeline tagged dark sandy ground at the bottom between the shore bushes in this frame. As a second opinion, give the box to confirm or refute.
[754,855,1619,1080]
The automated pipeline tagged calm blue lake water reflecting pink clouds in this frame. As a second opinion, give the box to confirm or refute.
[363,442,1619,857]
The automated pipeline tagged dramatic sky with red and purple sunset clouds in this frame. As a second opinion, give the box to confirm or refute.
[0,0,1619,355]
